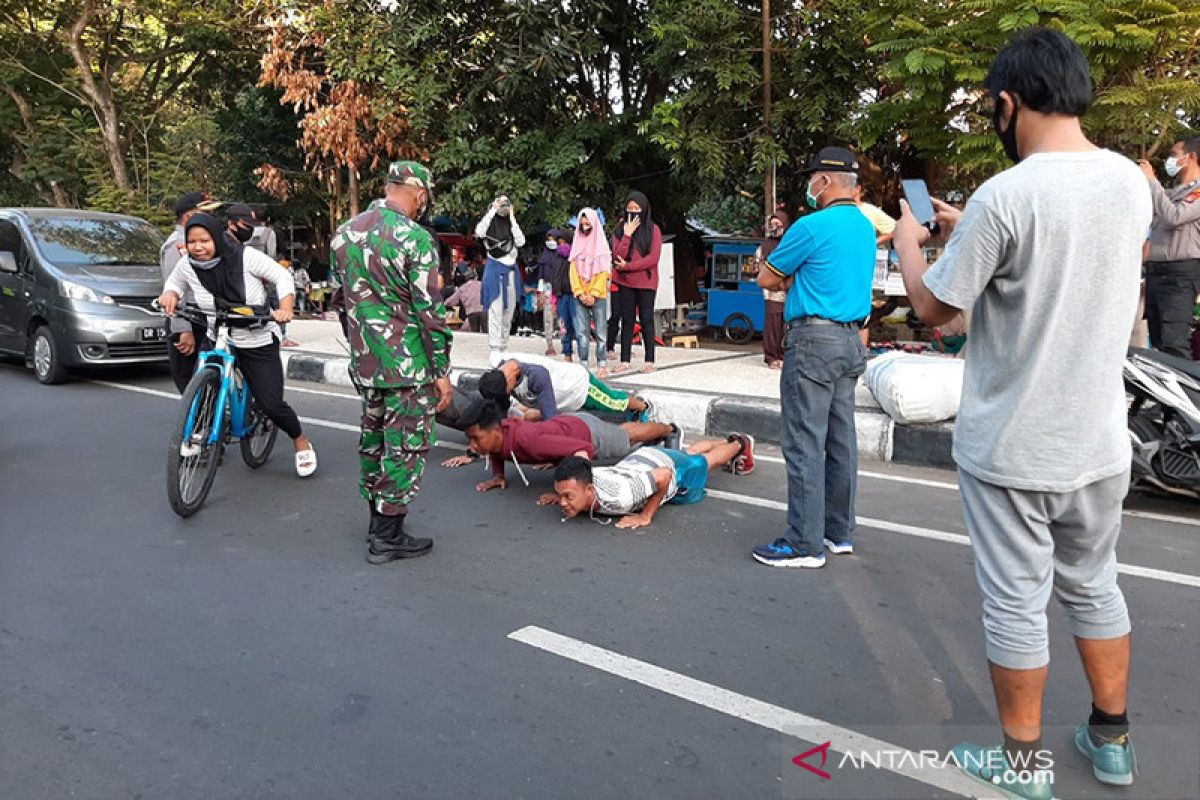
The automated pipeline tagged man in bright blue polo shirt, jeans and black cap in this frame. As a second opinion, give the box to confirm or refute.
[754,148,875,567]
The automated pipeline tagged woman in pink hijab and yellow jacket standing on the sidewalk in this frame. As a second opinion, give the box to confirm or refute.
[568,209,612,378]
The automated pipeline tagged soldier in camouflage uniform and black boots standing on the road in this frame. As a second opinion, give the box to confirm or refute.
[330,161,452,564]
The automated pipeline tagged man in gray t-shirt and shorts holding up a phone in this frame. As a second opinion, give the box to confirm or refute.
[893,29,1151,798]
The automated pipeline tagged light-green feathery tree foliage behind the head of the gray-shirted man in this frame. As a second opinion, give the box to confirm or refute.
[859,0,1200,184]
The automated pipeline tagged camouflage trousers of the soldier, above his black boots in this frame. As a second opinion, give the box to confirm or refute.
[359,384,438,516]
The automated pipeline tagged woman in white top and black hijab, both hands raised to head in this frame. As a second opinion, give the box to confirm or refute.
[475,194,524,355]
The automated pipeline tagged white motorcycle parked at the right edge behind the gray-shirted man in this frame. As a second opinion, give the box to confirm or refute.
[1124,349,1200,498]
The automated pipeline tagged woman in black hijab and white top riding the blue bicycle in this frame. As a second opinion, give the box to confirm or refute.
[158,213,317,477]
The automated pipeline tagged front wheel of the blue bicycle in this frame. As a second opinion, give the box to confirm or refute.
[167,369,224,517]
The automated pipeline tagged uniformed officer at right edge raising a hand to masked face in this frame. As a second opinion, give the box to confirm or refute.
[1138,136,1200,359]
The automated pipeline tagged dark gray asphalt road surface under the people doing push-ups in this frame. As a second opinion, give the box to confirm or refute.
[0,365,1200,800]
